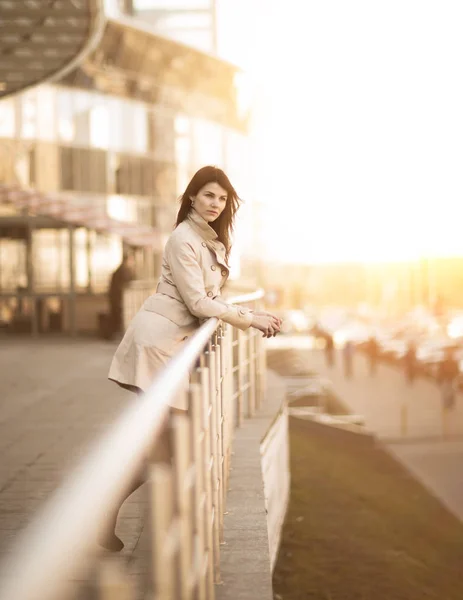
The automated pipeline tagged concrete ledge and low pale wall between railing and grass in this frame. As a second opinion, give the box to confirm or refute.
[216,371,289,600]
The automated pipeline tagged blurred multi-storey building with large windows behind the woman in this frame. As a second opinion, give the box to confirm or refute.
[0,17,247,333]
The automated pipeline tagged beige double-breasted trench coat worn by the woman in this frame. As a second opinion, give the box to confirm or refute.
[108,211,252,410]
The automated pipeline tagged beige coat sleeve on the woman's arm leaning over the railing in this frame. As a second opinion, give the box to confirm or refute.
[165,238,253,330]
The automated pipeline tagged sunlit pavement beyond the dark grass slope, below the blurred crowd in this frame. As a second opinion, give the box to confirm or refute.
[304,350,463,520]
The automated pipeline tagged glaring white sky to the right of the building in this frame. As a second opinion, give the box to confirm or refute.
[220,0,463,262]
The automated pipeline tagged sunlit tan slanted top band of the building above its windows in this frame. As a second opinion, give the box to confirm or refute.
[61,17,249,132]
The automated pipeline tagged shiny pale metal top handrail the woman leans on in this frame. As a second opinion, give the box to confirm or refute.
[0,290,263,600]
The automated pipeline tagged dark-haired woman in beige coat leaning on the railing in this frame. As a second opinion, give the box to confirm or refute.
[100,166,281,551]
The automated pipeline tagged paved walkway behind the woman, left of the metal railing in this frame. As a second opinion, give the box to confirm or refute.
[0,338,146,559]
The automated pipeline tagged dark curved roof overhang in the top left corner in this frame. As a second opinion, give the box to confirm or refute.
[0,0,105,98]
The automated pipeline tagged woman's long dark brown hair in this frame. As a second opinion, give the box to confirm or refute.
[175,166,241,261]
